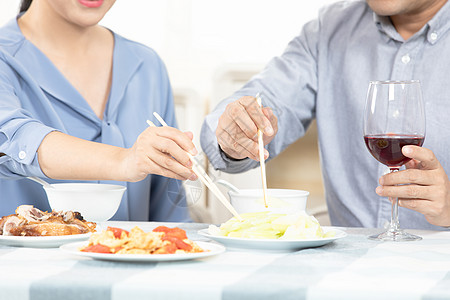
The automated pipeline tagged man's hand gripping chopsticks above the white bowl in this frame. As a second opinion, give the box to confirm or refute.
[216,96,278,161]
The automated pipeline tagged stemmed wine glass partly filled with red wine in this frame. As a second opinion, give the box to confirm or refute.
[364,80,425,241]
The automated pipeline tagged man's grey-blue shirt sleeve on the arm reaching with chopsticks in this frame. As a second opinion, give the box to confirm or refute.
[201,20,320,173]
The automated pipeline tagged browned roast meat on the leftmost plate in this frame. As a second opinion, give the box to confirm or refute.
[0,205,96,236]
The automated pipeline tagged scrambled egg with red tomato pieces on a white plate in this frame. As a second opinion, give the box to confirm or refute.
[80,226,204,254]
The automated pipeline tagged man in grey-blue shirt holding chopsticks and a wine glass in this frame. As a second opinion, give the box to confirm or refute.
[201,0,450,230]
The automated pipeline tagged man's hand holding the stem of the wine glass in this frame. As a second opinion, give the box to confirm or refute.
[376,146,450,226]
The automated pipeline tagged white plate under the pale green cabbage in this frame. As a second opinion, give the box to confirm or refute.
[198,226,347,251]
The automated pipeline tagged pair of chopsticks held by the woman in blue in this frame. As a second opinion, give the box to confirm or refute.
[147,112,243,221]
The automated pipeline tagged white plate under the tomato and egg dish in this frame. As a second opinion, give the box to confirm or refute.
[59,241,225,262]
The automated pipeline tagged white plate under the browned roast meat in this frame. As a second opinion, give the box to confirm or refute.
[0,233,91,248]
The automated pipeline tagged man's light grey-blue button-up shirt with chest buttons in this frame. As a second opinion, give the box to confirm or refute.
[201,1,450,229]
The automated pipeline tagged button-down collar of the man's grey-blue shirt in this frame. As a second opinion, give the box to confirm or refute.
[373,1,450,44]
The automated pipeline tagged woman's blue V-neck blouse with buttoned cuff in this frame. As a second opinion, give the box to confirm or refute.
[0,19,189,221]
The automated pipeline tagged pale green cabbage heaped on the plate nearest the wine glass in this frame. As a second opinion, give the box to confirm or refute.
[208,212,335,240]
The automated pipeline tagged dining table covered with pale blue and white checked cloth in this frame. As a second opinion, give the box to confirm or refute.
[0,221,450,300]
